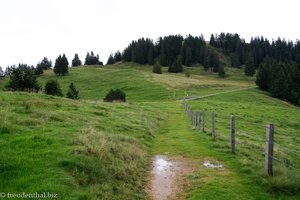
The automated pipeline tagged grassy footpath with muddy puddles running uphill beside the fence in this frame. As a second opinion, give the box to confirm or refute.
[146,101,266,200]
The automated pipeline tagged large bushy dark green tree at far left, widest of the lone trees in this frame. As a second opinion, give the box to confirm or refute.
[5,64,41,92]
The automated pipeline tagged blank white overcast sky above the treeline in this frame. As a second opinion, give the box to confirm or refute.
[0,0,300,67]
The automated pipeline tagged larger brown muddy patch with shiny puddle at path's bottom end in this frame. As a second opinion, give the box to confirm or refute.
[147,155,183,200]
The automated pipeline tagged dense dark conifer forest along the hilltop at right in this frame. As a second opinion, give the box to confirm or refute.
[107,33,300,105]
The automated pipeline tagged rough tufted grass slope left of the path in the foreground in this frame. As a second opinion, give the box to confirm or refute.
[0,92,162,199]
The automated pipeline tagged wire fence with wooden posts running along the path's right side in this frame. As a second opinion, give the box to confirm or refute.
[182,99,300,175]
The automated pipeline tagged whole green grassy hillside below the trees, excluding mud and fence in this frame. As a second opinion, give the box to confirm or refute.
[0,63,300,199]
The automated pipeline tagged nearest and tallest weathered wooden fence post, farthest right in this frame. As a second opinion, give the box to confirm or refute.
[265,124,274,176]
